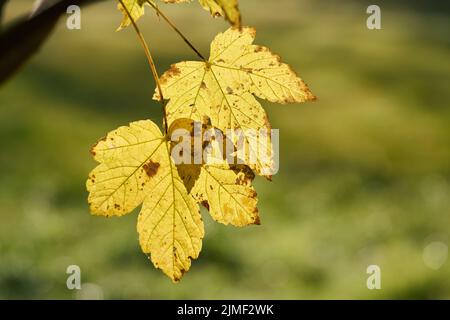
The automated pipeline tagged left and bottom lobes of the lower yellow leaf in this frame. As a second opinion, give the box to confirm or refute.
[87,120,204,282]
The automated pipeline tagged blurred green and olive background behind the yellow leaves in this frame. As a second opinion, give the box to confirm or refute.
[0,0,450,299]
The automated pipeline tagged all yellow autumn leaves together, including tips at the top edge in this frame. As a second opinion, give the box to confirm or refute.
[87,0,315,282]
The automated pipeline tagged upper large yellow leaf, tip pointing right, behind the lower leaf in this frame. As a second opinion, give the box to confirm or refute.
[154,27,315,177]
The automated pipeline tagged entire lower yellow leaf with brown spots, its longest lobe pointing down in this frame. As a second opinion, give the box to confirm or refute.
[86,120,259,282]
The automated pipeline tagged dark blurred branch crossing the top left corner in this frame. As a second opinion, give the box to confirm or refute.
[0,0,102,85]
